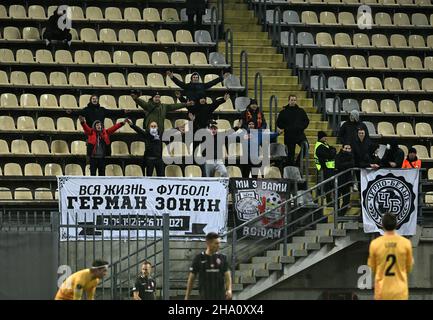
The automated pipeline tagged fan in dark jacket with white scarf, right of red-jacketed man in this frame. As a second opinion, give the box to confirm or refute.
[128,120,165,177]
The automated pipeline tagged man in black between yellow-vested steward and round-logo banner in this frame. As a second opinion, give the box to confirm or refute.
[335,144,355,215]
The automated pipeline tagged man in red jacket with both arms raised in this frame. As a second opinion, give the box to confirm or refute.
[79,116,127,176]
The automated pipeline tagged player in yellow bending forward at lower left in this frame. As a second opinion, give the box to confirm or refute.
[55,260,108,300]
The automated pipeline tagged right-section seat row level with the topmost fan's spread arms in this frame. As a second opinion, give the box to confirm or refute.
[311,76,433,93]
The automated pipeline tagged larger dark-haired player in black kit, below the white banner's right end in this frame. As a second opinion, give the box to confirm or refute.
[185,232,232,300]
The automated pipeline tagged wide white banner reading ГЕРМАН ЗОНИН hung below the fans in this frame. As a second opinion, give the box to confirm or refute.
[58,176,229,241]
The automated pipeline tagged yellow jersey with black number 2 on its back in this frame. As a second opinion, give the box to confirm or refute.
[368,234,413,300]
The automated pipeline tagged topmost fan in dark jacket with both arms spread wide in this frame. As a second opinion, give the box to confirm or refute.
[167,71,230,104]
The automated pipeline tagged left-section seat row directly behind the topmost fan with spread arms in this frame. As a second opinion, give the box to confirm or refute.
[0,70,233,88]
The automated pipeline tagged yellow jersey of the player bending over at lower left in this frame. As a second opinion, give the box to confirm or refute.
[55,269,99,300]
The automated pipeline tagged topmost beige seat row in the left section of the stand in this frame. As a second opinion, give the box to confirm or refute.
[0,5,211,22]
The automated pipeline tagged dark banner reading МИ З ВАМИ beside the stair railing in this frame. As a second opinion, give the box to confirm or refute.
[230,178,289,239]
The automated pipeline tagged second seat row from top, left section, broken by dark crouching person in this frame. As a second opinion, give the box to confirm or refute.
[0,26,213,44]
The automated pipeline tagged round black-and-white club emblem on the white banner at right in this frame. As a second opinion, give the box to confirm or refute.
[362,173,415,228]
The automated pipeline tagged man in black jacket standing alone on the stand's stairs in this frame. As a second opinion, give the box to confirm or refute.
[277,95,310,166]
